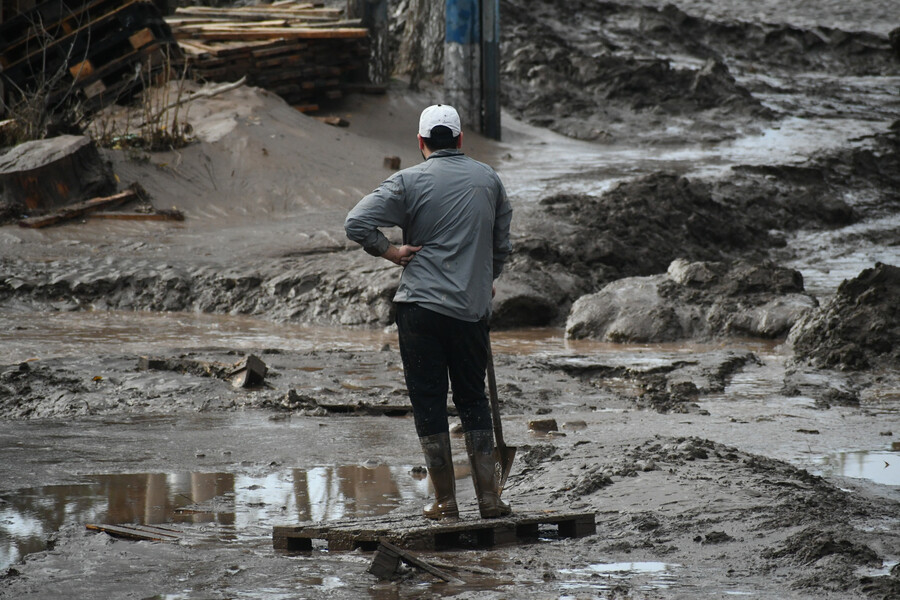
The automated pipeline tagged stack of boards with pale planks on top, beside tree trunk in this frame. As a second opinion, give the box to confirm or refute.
[166,0,369,111]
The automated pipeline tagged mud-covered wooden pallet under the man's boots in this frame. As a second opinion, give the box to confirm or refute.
[272,512,597,552]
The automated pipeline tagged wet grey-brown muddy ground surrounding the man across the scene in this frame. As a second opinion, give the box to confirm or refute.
[0,0,900,599]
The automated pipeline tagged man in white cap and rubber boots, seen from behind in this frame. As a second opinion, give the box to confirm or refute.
[344,104,512,519]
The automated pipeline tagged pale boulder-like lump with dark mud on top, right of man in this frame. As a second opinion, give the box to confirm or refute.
[566,259,817,342]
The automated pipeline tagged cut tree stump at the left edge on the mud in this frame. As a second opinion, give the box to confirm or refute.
[0,135,116,216]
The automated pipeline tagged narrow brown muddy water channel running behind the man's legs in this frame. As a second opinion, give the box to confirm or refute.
[0,311,773,364]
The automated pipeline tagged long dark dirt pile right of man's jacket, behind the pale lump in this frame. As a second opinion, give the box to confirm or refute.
[495,161,856,327]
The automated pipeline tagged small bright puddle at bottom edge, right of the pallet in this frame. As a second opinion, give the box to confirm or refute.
[559,562,680,591]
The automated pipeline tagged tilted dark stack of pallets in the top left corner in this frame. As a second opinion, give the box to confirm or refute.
[0,0,181,111]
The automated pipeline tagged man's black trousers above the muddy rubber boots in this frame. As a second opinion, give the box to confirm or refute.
[397,303,491,437]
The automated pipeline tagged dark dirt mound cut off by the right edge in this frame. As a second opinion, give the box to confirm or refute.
[789,263,900,370]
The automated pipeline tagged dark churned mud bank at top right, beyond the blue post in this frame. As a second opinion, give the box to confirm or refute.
[501,0,897,144]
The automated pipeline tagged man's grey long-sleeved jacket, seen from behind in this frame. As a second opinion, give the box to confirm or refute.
[344,150,512,322]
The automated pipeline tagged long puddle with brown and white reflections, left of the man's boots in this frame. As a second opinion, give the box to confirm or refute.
[0,465,428,569]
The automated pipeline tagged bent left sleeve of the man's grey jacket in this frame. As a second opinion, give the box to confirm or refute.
[344,173,406,256]
